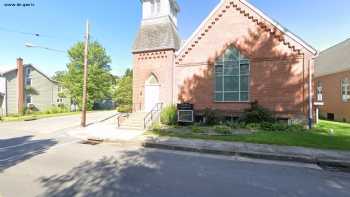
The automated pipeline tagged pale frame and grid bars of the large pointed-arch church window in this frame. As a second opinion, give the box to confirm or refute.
[214,48,251,103]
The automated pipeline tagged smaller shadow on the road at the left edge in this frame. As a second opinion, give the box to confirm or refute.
[0,136,57,173]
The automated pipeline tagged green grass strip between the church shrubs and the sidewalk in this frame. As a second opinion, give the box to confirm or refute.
[151,121,350,151]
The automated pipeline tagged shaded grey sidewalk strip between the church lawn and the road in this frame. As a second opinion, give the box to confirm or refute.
[143,137,350,169]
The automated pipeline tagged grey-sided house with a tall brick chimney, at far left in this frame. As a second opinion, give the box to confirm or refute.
[0,58,70,115]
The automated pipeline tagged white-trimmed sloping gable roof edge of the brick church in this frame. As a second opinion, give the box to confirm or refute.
[177,0,317,60]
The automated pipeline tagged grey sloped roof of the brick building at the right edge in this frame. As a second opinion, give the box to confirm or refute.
[315,38,350,77]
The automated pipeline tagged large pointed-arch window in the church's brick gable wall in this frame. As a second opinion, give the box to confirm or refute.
[215,47,250,102]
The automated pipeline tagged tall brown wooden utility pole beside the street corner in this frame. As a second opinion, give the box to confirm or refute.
[81,21,89,127]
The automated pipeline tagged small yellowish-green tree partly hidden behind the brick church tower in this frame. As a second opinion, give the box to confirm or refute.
[114,69,133,112]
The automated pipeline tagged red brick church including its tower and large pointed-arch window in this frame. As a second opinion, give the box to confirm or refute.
[132,0,317,121]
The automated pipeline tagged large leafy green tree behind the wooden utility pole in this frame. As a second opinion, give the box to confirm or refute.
[62,41,114,110]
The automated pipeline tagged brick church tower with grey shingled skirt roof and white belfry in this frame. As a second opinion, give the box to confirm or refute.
[132,0,181,111]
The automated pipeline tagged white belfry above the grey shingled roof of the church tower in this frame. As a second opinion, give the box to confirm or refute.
[141,0,180,26]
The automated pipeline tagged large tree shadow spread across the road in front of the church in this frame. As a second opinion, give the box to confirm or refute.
[37,149,350,197]
